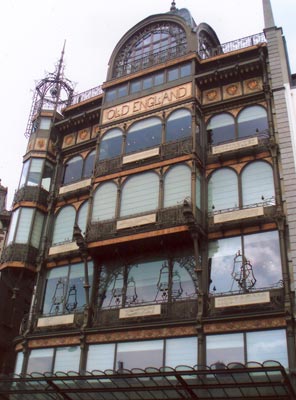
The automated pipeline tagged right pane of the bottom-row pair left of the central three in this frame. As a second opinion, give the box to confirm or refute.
[53,346,80,372]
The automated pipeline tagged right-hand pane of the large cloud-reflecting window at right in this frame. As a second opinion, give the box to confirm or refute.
[244,231,282,288]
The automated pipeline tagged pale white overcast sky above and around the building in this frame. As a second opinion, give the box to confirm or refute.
[0,0,296,206]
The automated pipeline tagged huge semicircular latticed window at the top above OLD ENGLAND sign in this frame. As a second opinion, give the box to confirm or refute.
[113,22,187,77]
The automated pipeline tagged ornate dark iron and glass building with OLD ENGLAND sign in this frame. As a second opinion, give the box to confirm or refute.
[0,0,296,400]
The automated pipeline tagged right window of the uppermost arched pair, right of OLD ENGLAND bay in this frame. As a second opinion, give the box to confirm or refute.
[237,106,268,138]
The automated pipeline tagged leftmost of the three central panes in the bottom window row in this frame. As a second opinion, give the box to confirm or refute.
[86,343,115,372]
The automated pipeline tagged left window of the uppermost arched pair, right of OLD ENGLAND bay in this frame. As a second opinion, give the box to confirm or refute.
[207,113,235,145]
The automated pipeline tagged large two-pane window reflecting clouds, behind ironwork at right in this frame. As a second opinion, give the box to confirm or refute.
[209,231,282,293]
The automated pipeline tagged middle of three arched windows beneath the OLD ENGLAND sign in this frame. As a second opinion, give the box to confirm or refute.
[125,117,162,153]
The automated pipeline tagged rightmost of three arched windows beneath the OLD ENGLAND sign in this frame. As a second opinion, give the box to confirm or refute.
[166,109,192,142]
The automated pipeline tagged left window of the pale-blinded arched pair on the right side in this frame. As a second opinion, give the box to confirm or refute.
[208,168,239,211]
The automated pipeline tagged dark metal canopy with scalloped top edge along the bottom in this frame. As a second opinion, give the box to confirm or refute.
[0,362,296,400]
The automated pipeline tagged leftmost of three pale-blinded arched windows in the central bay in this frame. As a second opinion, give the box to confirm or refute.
[91,182,117,221]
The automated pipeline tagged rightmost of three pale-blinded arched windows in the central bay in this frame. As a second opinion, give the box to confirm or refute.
[164,165,191,207]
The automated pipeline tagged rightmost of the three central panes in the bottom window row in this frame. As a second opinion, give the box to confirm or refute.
[165,337,197,368]
